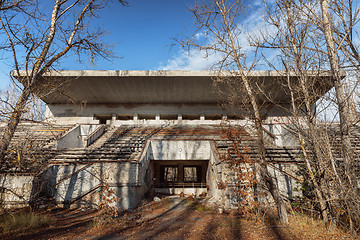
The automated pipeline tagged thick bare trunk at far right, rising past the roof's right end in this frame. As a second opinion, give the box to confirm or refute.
[320,0,355,184]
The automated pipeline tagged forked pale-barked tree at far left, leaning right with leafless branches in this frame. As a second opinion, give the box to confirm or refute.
[0,0,120,169]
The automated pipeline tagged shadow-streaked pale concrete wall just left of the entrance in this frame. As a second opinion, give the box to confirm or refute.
[44,162,148,209]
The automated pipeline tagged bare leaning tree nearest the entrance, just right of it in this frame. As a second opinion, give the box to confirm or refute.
[180,0,288,223]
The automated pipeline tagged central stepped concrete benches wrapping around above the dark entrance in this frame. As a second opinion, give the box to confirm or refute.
[47,126,301,163]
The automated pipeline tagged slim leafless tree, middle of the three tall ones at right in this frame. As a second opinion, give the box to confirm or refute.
[252,0,329,221]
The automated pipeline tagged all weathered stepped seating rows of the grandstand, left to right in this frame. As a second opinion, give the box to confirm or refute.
[4,122,360,172]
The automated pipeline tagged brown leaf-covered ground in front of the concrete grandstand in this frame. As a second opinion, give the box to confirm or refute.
[0,198,360,240]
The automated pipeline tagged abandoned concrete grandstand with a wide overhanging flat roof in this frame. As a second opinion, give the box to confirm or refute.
[0,71,350,209]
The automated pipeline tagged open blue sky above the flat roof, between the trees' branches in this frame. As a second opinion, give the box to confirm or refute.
[0,0,261,89]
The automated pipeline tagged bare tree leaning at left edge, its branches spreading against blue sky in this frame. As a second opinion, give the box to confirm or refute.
[0,0,127,168]
